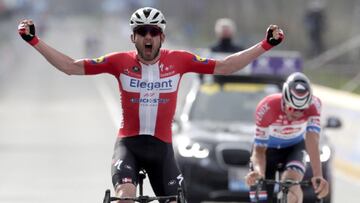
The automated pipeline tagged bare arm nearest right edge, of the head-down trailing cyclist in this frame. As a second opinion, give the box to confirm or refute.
[305,131,323,177]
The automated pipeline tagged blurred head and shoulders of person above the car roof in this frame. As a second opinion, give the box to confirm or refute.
[210,18,243,53]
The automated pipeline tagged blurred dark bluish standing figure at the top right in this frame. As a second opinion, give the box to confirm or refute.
[304,0,326,56]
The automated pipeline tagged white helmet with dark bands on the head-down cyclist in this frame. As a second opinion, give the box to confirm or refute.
[282,72,312,109]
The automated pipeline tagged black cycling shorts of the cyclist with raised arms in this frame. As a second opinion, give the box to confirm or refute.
[111,135,185,196]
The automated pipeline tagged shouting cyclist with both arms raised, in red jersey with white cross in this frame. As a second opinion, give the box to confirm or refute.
[18,7,284,203]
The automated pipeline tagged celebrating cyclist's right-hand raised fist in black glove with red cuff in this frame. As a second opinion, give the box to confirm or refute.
[261,25,284,50]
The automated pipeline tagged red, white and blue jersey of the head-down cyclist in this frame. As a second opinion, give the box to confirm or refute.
[255,94,321,148]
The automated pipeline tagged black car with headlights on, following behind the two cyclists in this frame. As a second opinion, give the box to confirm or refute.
[173,75,339,203]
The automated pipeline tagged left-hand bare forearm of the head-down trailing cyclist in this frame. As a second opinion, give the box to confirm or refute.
[250,145,267,177]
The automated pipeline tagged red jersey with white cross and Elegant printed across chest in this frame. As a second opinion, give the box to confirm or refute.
[84,49,215,143]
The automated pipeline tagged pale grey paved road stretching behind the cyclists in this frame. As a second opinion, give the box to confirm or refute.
[0,15,360,203]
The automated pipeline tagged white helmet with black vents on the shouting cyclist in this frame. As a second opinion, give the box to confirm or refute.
[130,7,166,32]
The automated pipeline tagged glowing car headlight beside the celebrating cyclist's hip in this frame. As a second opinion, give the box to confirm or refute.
[177,137,209,159]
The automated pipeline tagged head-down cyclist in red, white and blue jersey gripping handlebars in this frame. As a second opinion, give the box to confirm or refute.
[245,72,329,203]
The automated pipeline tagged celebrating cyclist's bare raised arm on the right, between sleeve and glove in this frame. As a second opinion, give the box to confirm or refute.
[214,43,266,75]
